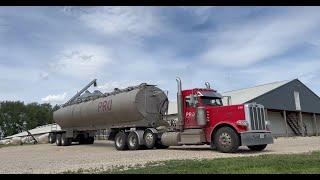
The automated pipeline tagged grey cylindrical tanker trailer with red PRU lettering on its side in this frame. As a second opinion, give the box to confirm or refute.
[49,79,168,150]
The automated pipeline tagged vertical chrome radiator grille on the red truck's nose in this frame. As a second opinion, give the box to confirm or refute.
[248,106,266,130]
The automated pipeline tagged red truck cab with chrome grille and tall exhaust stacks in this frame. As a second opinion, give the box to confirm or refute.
[170,79,273,152]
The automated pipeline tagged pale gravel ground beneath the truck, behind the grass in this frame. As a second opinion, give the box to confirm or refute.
[0,137,320,173]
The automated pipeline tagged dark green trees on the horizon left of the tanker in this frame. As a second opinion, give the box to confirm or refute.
[0,101,59,137]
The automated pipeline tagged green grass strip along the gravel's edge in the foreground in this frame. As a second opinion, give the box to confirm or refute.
[65,151,320,174]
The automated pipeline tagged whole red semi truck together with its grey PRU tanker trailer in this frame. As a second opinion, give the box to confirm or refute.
[49,78,273,153]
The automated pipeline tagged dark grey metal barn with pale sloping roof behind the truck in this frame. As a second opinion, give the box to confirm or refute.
[222,79,320,136]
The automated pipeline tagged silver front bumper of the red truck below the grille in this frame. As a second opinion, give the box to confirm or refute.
[240,132,273,146]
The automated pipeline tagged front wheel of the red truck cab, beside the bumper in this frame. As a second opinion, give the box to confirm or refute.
[214,127,240,153]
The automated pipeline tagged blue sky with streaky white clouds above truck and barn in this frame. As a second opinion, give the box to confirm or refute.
[0,7,320,104]
